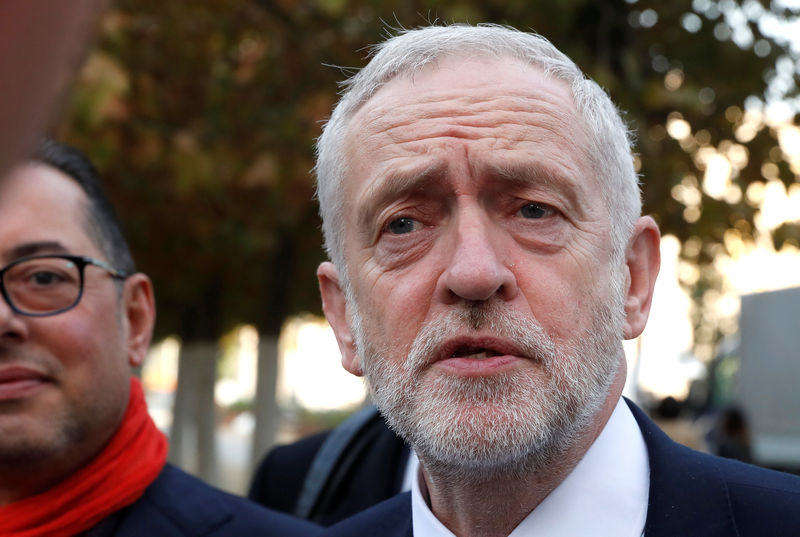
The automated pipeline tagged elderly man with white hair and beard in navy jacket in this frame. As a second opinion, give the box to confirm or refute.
[316,25,800,537]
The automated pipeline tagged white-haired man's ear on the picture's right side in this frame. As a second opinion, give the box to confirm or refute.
[624,216,661,339]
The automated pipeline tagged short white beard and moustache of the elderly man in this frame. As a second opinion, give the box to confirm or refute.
[351,293,623,478]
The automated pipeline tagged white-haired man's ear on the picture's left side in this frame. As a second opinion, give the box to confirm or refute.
[317,261,364,377]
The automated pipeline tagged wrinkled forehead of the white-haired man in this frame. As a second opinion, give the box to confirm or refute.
[343,52,590,195]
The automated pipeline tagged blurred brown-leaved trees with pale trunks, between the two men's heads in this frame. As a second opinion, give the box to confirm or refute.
[61,0,333,478]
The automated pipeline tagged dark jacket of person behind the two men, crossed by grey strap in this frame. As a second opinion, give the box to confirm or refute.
[248,412,409,526]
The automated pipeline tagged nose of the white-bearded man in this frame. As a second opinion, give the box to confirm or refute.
[437,215,518,302]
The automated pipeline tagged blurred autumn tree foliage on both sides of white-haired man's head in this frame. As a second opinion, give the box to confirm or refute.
[54,0,800,472]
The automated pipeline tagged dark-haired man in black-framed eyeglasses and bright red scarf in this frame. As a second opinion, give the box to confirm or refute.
[0,142,317,537]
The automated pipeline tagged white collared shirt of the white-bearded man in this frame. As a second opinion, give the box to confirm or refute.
[407,399,650,537]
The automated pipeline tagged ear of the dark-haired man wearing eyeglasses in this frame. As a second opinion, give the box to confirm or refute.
[122,272,156,367]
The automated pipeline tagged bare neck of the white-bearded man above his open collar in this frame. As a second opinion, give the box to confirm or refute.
[420,389,619,537]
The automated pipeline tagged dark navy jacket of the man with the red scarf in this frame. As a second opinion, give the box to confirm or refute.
[86,465,321,537]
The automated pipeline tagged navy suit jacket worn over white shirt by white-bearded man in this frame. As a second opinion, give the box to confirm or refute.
[324,403,800,537]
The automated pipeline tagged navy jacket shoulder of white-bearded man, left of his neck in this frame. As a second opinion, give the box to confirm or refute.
[325,492,412,537]
